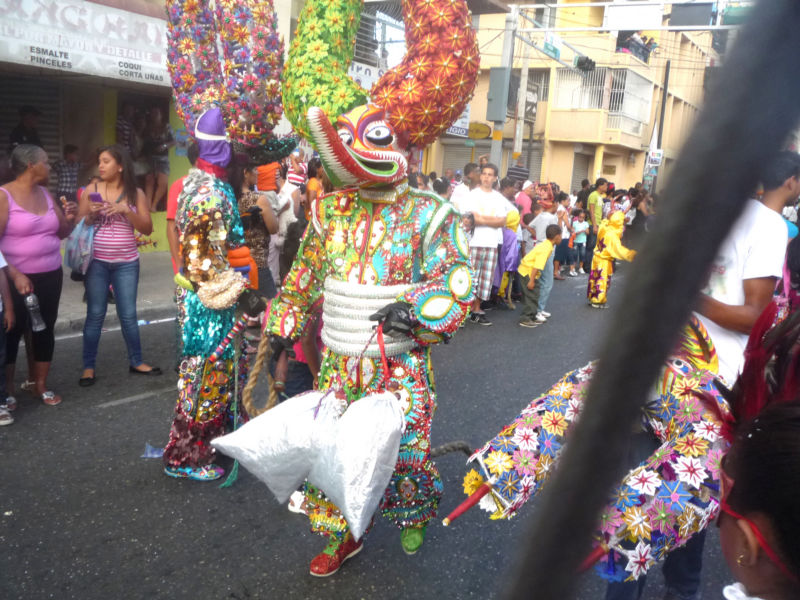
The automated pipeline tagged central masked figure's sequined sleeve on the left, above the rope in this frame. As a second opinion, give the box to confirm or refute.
[264,217,327,340]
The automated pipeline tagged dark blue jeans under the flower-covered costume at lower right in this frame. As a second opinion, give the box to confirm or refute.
[606,433,706,600]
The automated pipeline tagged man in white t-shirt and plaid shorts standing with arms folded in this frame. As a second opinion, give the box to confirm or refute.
[462,164,511,325]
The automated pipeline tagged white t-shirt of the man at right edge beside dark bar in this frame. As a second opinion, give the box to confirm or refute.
[697,200,789,385]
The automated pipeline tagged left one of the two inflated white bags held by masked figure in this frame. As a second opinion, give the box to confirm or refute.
[211,392,342,502]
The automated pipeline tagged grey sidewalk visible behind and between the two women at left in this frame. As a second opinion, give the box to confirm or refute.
[55,252,176,336]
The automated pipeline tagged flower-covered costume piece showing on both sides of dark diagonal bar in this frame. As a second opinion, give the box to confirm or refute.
[464,319,729,581]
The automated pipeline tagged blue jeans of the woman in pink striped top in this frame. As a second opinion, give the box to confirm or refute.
[83,259,142,369]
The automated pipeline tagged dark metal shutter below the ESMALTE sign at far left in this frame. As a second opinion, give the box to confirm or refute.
[0,75,62,188]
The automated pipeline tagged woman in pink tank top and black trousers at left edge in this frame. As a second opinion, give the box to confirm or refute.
[0,144,76,405]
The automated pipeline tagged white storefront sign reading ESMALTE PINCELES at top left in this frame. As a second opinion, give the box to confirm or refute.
[0,0,170,86]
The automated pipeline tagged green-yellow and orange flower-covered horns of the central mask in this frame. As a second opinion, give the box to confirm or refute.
[283,0,479,148]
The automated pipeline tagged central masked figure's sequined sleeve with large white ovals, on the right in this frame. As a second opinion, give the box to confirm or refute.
[398,204,474,345]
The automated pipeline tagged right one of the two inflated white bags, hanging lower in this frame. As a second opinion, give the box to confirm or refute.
[308,392,405,539]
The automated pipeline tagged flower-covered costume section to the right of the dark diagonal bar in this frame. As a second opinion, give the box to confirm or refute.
[597,363,728,581]
